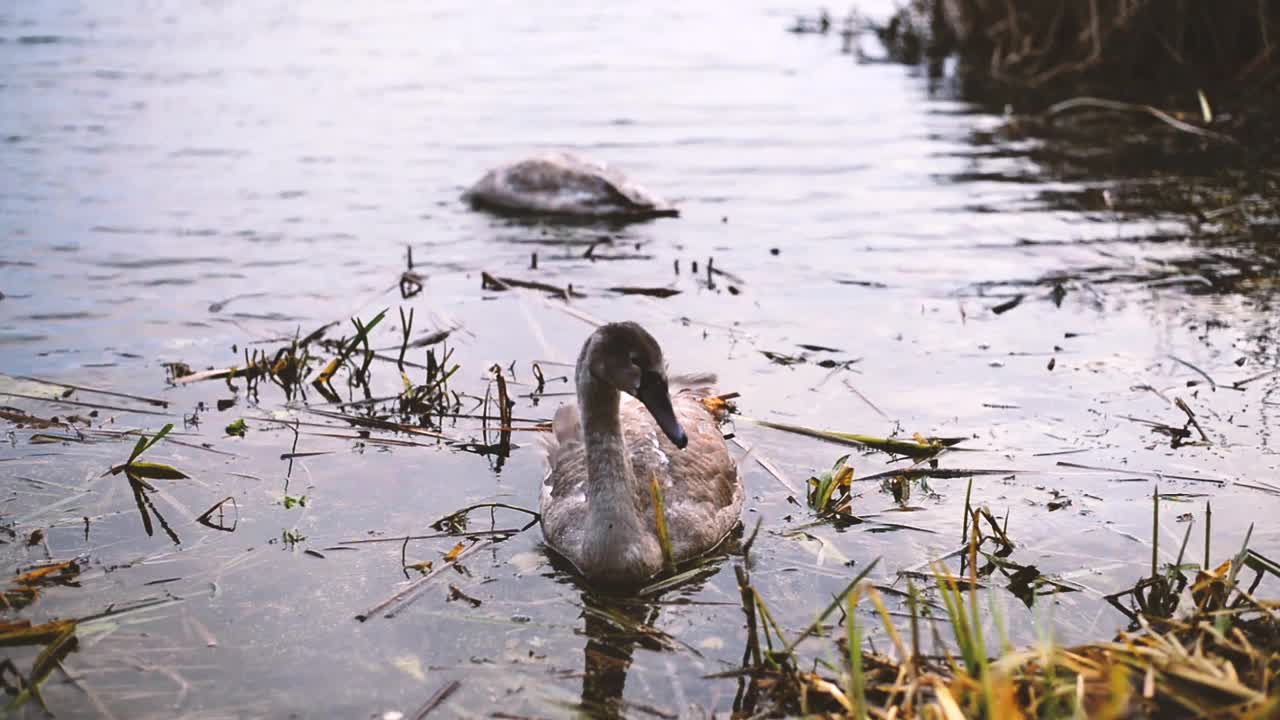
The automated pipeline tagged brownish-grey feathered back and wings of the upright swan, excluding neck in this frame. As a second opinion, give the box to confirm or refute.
[540,377,744,568]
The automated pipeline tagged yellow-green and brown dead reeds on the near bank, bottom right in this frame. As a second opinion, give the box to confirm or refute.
[722,491,1280,720]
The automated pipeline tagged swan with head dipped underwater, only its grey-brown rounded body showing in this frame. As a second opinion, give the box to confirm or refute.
[462,152,680,219]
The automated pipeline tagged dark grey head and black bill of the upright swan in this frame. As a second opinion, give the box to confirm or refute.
[577,323,689,450]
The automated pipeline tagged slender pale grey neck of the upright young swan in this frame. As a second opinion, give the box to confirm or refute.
[577,372,660,574]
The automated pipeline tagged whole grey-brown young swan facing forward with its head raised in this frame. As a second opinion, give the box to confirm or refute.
[541,323,744,584]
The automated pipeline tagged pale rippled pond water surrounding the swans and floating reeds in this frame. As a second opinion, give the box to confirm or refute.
[0,1,1280,717]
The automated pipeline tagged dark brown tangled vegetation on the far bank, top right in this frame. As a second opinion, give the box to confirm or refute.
[788,0,1280,240]
